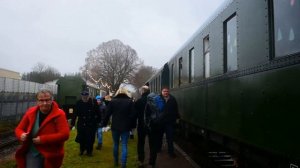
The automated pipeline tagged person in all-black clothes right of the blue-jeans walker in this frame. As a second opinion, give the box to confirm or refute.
[135,86,150,166]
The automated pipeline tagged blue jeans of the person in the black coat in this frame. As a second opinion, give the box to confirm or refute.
[112,131,129,166]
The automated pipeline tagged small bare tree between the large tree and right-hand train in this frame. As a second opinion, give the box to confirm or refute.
[132,65,157,88]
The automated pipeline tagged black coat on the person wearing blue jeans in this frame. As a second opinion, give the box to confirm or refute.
[103,94,136,132]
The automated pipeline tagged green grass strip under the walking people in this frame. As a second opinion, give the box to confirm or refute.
[0,130,137,168]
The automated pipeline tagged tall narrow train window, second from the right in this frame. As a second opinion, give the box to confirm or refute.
[224,15,237,72]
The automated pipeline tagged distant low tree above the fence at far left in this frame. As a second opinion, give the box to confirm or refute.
[22,62,61,83]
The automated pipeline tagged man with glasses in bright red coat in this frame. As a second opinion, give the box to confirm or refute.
[15,89,69,168]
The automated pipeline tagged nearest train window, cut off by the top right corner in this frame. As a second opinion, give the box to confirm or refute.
[274,0,300,57]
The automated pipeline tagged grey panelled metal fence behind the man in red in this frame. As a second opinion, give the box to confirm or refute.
[0,77,57,120]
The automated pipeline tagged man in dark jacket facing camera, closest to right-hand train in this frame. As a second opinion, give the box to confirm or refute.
[158,87,180,158]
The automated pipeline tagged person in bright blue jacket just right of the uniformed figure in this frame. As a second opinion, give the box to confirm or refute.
[96,96,106,150]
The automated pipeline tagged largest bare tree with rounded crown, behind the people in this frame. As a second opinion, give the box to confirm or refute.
[81,40,142,91]
